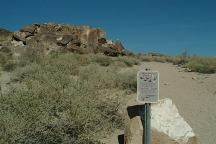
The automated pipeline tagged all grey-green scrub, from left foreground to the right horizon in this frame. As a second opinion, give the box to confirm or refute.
[0,41,216,144]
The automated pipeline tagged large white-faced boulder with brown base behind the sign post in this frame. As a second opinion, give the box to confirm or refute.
[125,99,197,144]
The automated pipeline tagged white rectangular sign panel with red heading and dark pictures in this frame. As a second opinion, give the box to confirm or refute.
[137,70,159,103]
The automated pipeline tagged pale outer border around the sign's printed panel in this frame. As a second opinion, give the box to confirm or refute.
[136,70,160,104]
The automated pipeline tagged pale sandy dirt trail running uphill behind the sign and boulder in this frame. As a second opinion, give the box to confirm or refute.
[106,62,216,144]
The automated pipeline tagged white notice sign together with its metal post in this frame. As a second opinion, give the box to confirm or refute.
[137,68,159,144]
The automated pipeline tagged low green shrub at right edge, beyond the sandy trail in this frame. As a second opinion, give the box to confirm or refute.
[184,57,216,73]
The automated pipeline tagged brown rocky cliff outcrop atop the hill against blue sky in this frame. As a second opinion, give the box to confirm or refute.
[0,24,128,56]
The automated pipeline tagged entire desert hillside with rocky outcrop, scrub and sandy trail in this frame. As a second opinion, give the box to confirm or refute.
[0,24,216,144]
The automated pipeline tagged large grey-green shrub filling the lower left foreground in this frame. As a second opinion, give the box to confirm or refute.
[0,81,111,144]
